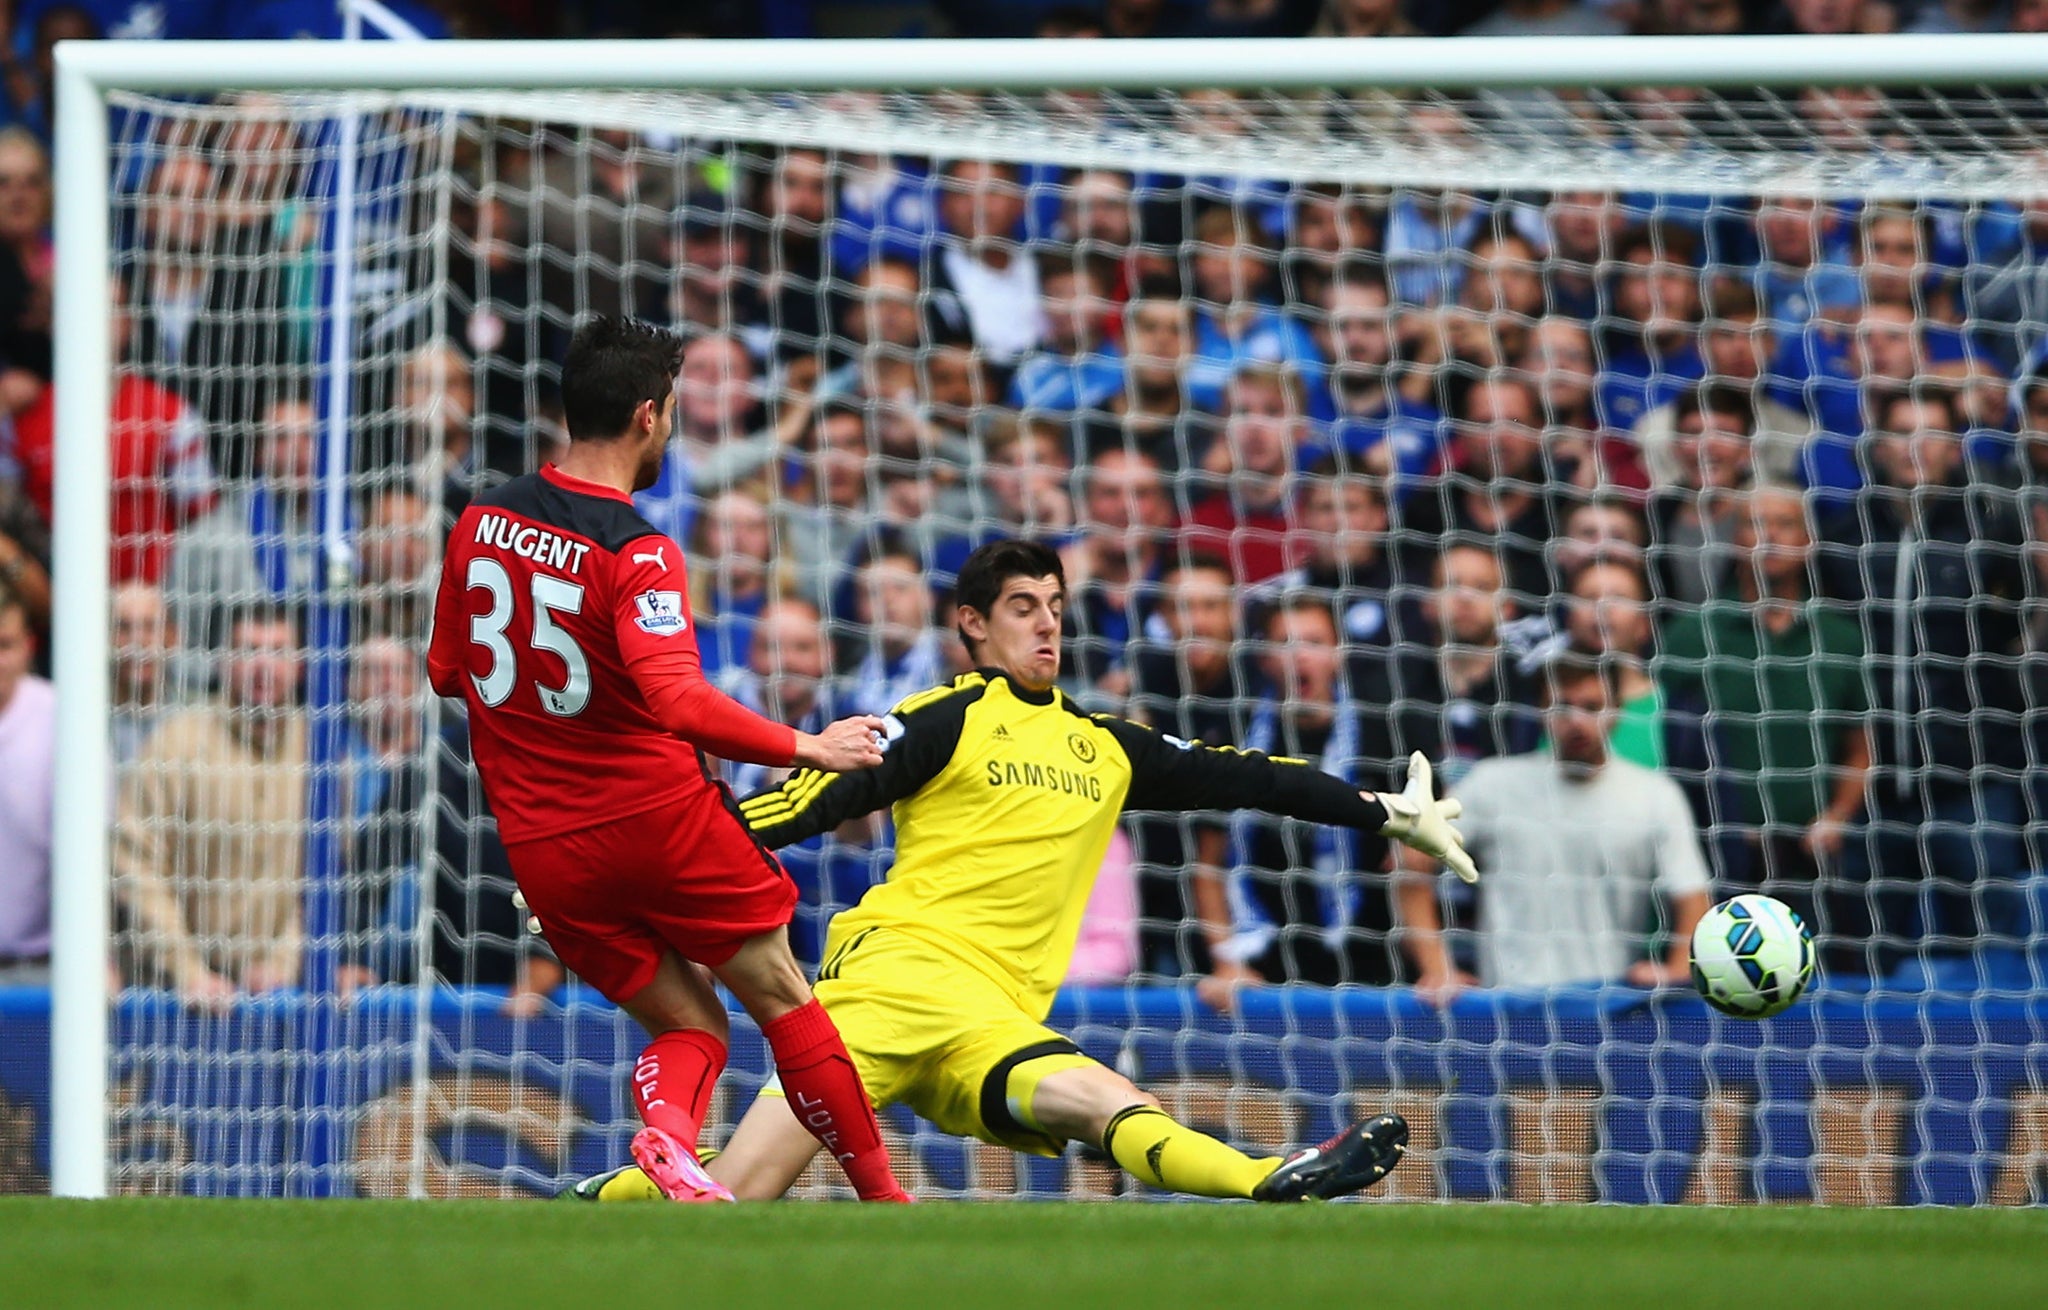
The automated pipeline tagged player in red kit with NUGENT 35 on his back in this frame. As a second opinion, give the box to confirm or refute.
[428,317,907,1199]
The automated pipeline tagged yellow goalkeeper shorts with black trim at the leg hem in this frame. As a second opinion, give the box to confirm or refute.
[798,927,1094,1156]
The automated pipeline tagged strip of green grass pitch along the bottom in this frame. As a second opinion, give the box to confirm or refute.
[0,1199,2048,1310]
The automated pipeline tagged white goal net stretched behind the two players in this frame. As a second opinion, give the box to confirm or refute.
[28,51,2048,1204]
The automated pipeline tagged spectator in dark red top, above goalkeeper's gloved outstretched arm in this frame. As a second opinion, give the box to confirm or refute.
[1178,362,1313,583]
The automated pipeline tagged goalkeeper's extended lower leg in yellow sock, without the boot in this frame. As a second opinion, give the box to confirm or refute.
[1032,1062,1280,1199]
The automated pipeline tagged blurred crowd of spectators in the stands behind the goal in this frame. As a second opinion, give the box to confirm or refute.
[0,0,2048,1009]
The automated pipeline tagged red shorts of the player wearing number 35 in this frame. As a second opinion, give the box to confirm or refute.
[506,788,797,1003]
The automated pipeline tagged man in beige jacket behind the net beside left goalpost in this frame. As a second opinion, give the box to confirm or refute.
[113,606,307,1007]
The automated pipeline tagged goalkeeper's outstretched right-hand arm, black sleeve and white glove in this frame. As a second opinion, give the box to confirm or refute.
[1096,714,1479,882]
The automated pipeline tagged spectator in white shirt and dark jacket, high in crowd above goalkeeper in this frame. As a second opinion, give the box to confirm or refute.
[926,160,1044,368]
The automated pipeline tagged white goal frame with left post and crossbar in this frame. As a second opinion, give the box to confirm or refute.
[51,35,2048,1197]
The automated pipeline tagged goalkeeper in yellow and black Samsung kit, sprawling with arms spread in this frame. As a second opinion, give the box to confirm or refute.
[575,540,1477,1202]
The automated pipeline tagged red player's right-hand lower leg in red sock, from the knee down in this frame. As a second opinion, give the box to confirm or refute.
[715,927,909,1202]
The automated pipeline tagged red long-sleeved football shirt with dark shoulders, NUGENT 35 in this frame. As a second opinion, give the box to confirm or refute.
[428,465,797,841]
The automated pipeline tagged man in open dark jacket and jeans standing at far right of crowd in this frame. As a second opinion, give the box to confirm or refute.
[1821,391,2028,962]
